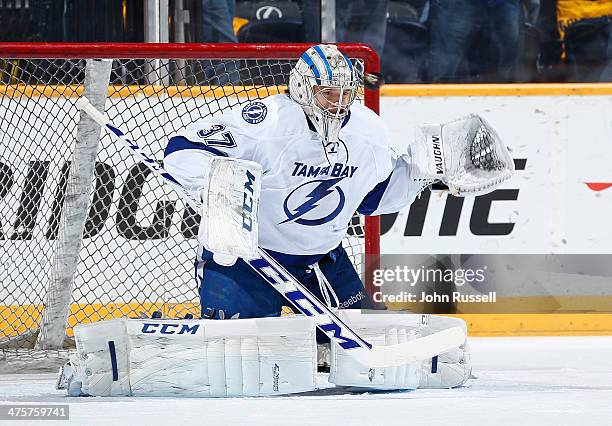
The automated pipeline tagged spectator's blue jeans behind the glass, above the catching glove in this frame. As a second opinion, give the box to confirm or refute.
[428,0,521,83]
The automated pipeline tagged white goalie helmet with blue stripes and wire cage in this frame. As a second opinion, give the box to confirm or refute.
[289,44,361,143]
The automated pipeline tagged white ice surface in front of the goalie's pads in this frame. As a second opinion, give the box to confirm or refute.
[0,337,612,426]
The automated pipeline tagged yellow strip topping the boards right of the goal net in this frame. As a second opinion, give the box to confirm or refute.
[380,83,612,97]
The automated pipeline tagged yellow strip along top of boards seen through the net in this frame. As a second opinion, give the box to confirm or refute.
[0,84,287,99]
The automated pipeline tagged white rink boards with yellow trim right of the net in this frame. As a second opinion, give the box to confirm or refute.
[381,83,612,326]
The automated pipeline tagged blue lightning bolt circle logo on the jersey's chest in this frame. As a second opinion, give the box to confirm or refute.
[279,177,345,226]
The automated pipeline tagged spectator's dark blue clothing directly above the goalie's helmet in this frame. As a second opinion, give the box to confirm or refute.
[336,0,388,57]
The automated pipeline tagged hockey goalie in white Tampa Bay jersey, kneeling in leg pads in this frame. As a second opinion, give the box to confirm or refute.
[60,45,514,397]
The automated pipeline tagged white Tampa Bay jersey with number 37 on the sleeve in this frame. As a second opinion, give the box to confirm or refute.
[164,95,421,257]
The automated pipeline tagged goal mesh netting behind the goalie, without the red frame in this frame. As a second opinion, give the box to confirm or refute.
[0,51,376,366]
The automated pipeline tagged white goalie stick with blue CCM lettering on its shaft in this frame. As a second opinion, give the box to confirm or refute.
[76,97,465,368]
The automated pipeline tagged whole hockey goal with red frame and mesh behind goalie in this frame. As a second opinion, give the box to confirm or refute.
[0,43,379,371]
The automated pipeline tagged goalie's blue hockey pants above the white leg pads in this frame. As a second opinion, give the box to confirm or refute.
[196,246,368,319]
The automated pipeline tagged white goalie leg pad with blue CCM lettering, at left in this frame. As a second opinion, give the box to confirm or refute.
[75,317,316,397]
